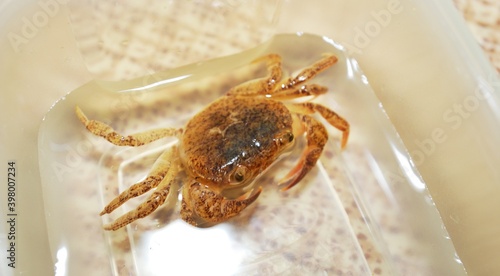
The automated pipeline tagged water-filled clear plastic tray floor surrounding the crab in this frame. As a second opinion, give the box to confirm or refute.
[39,33,464,275]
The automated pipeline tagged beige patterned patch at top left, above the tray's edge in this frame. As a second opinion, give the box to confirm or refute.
[70,0,279,80]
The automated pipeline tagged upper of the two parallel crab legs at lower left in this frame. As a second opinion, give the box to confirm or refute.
[99,147,176,216]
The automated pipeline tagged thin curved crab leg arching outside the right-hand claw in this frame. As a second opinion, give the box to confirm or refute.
[287,102,350,148]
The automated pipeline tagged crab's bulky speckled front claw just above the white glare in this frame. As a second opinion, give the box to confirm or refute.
[181,182,262,227]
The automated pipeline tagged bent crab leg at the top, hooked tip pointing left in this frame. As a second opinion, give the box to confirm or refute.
[227,54,283,96]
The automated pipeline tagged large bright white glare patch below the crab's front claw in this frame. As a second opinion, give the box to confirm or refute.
[144,220,244,275]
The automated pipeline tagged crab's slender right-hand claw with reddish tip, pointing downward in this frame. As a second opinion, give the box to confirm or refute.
[279,114,328,190]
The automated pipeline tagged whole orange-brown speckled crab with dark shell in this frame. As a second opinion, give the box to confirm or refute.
[75,54,349,230]
